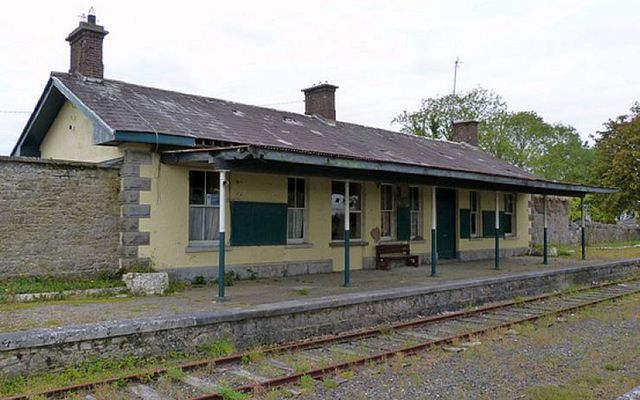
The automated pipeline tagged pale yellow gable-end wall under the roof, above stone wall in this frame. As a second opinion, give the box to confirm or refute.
[40,101,122,162]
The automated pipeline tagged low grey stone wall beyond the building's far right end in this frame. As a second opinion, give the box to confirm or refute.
[531,196,640,245]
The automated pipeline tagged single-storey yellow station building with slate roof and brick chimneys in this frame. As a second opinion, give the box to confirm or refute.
[12,15,610,290]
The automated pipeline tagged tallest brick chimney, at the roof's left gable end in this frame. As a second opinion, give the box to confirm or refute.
[66,9,109,79]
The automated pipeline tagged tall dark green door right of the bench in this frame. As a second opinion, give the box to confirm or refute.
[436,189,456,258]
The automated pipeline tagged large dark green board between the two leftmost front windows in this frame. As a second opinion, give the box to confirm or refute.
[231,201,287,246]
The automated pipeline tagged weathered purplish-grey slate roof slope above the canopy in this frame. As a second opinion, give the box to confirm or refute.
[52,73,541,180]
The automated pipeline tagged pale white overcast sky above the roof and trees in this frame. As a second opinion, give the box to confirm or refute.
[0,0,640,154]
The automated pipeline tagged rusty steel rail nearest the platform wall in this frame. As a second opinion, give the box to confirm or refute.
[6,277,640,400]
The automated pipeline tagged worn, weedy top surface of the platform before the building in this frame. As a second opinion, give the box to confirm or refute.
[0,257,624,332]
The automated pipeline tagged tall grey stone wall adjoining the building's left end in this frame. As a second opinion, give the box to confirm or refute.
[0,157,120,278]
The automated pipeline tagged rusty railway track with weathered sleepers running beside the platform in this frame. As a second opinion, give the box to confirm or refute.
[6,278,640,400]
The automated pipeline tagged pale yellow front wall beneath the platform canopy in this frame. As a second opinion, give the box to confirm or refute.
[139,155,529,271]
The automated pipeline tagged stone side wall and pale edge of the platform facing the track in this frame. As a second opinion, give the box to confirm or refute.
[0,258,640,375]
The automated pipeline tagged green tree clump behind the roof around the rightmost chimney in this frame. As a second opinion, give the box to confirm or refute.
[392,88,594,182]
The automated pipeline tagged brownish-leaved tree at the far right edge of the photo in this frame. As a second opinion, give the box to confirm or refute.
[593,102,640,221]
